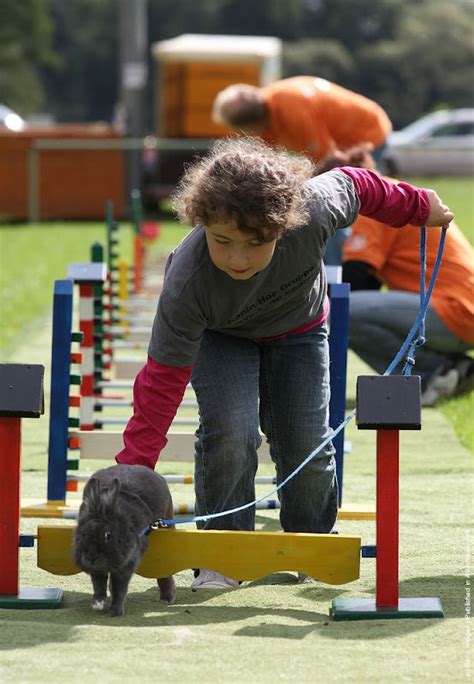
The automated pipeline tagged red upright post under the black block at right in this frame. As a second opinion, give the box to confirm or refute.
[375,430,399,607]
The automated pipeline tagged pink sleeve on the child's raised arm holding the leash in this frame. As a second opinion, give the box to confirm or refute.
[340,166,430,228]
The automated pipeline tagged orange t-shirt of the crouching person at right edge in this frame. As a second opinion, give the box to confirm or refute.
[343,216,474,344]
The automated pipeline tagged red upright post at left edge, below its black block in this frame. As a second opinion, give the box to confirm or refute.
[0,417,21,595]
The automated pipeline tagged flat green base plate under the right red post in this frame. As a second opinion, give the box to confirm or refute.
[329,598,444,620]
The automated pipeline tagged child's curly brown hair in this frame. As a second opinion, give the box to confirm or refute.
[172,137,315,241]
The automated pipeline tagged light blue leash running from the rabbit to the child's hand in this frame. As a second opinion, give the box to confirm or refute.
[153,226,447,536]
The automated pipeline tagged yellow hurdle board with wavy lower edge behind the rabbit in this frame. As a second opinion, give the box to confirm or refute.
[37,525,361,584]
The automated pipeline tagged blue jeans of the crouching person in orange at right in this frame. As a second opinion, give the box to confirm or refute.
[349,290,471,390]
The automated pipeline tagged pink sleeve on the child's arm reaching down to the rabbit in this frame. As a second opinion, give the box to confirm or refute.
[115,356,192,468]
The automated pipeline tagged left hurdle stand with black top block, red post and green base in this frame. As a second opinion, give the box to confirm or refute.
[0,364,63,608]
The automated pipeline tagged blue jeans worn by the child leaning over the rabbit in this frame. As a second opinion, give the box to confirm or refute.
[191,325,337,532]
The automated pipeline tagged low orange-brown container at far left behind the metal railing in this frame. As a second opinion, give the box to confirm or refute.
[0,124,126,220]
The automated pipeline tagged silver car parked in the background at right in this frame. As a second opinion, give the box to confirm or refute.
[382,109,474,177]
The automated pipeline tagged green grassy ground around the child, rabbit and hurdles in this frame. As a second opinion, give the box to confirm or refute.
[0,179,474,684]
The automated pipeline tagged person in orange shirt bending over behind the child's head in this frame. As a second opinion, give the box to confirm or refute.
[212,76,392,166]
